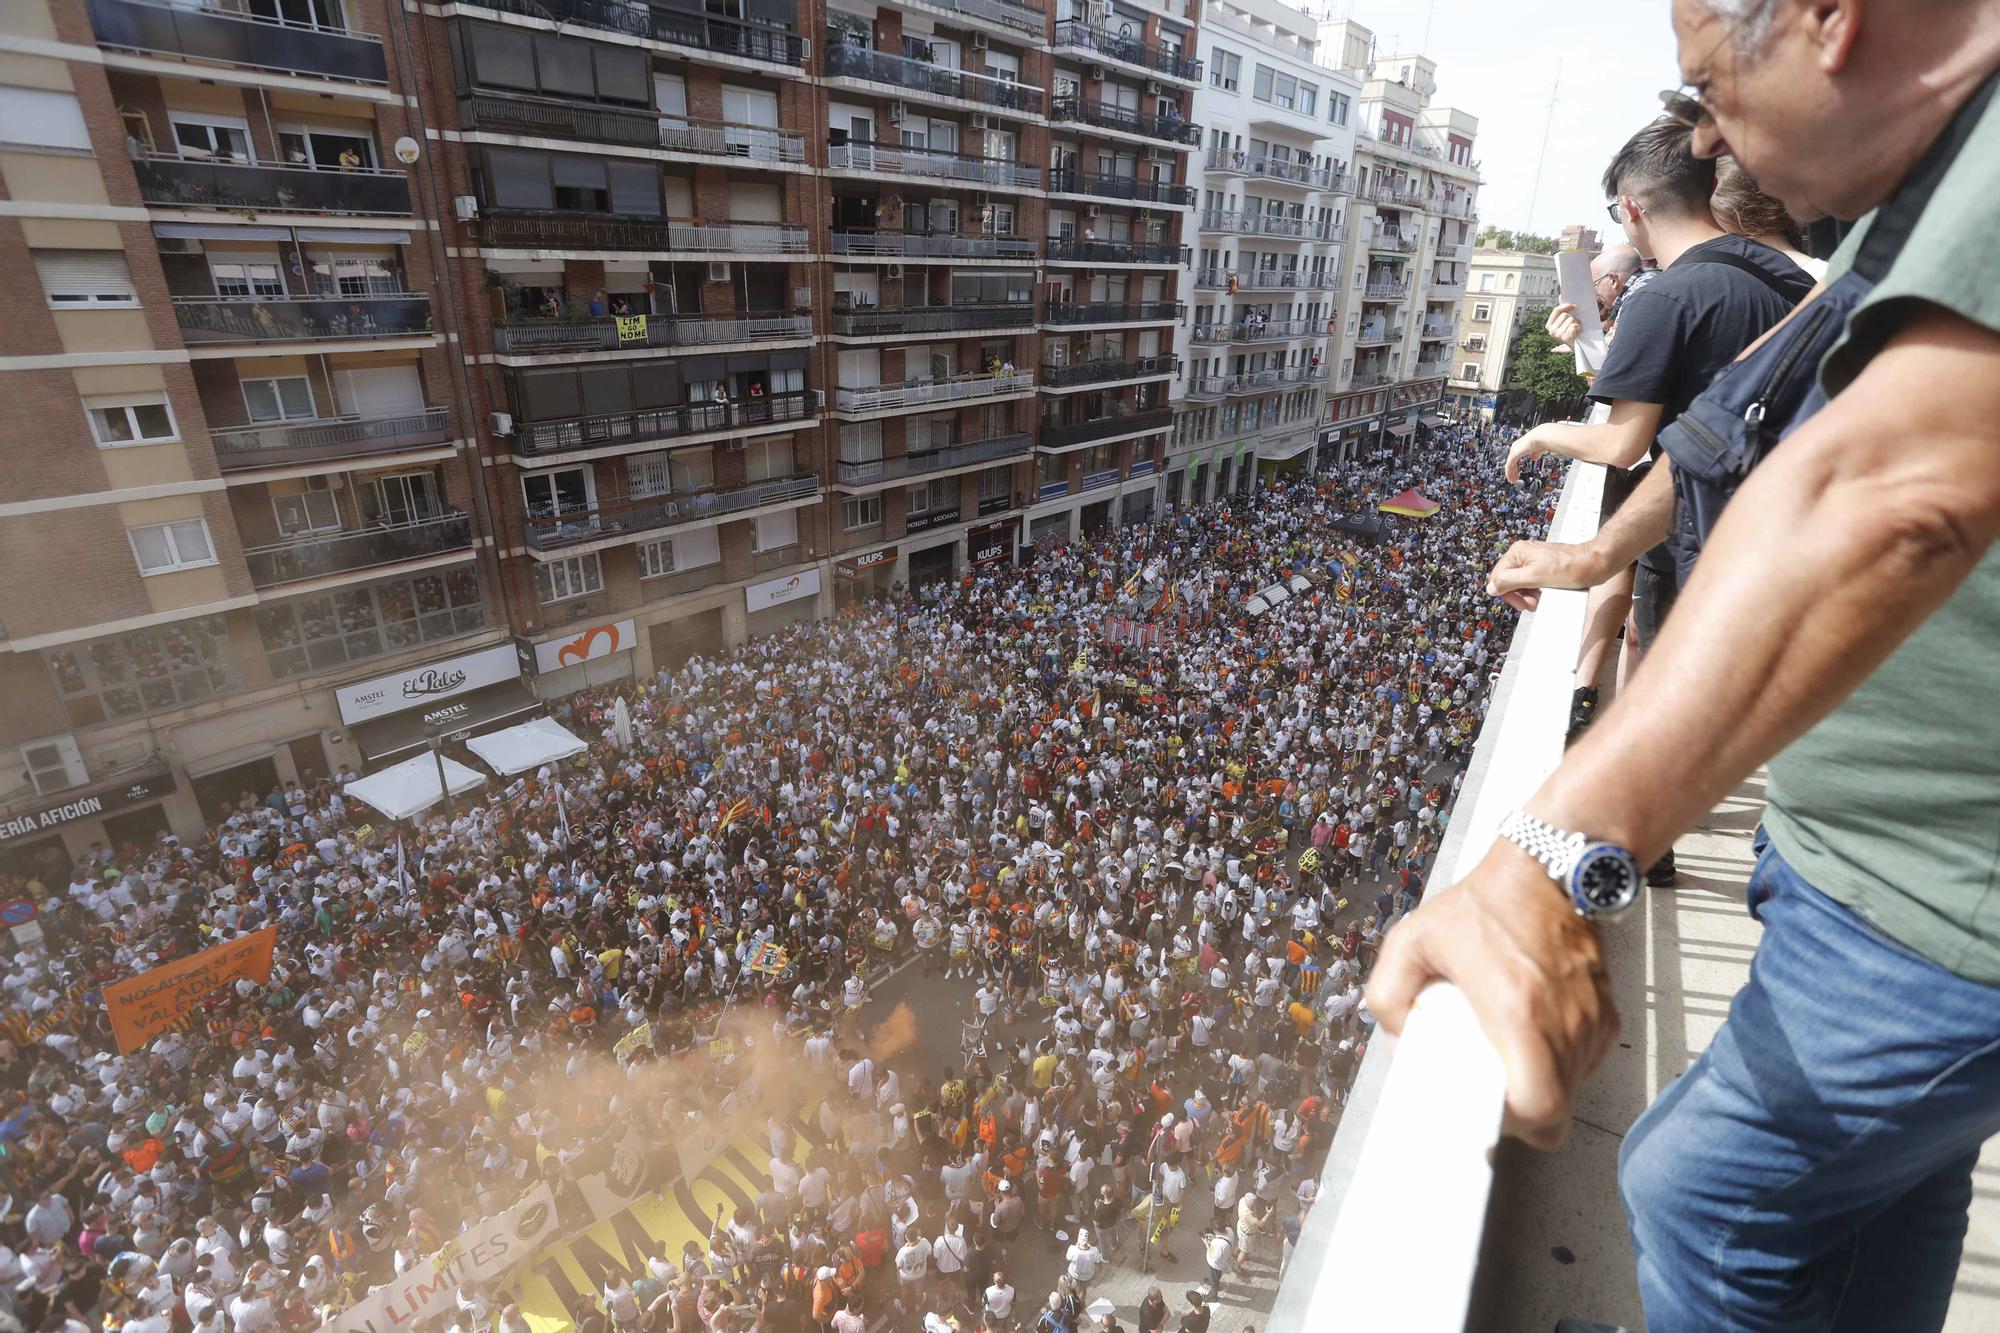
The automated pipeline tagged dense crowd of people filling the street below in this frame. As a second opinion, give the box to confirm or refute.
[0,428,1560,1333]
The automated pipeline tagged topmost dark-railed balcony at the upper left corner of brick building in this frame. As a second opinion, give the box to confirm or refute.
[88,0,388,84]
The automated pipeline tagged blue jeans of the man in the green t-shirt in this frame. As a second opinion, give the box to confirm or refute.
[1618,833,2000,1333]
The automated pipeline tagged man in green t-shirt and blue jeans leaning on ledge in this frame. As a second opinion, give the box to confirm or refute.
[1368,0,2000,1331]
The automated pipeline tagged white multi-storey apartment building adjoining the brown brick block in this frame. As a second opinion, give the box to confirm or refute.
[1166,0,1362,504]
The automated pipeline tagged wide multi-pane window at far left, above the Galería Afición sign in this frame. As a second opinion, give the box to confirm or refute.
[44,616,242,727]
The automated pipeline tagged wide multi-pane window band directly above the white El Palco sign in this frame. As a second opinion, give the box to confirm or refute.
[254,564,486,679]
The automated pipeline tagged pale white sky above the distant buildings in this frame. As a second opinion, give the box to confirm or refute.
[1312,0,1680,236]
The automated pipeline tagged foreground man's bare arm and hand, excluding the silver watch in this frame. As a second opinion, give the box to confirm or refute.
[1368,306,2000,1147]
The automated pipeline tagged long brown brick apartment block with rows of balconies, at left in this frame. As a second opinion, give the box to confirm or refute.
[0,0,1202,865]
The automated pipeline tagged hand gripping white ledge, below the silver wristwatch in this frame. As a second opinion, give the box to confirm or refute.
[1368,839,1618,1149]
